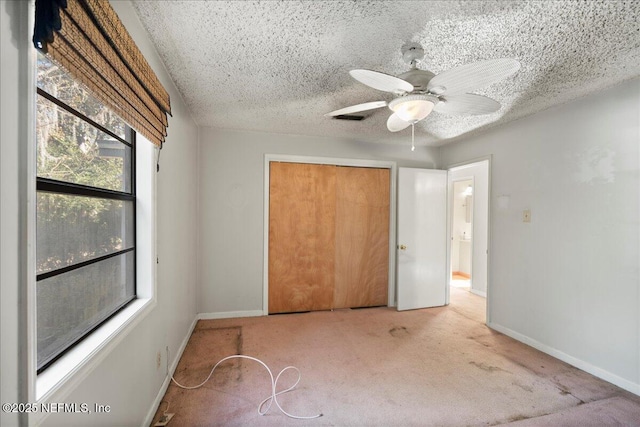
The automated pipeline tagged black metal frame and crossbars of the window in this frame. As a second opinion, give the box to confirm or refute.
[34,81,138,375]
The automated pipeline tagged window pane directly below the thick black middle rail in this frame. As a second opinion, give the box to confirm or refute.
[36,192,135,274]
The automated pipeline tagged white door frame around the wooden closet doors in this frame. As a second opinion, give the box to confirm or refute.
[262,154,398,316]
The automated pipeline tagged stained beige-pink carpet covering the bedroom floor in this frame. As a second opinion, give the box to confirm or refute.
[154,288,640,426]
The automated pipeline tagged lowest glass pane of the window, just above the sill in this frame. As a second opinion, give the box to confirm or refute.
[36,252,135,369]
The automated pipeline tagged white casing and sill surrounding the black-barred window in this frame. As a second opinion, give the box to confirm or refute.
[17,1,160,425]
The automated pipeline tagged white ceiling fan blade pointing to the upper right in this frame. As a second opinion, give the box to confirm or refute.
[427,58,520,95]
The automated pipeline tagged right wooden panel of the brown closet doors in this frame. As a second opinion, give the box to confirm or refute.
[334,167,391,308]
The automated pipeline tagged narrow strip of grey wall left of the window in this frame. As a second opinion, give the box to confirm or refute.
[0,1,28,426]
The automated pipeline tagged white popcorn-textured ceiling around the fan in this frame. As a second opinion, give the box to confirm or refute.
[133,0,640,146]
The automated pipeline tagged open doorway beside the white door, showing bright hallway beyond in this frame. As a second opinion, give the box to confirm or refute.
[447,159,490,322]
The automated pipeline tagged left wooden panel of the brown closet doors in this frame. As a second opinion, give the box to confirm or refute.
[269,162,336,313]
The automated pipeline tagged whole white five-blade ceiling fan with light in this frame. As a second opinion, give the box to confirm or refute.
[325,42,520,146]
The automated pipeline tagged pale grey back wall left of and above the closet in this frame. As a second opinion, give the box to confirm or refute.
[198,128,438,314]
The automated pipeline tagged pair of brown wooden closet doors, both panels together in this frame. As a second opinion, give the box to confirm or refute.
[268,162,390,313]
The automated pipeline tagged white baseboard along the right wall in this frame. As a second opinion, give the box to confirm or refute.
[487,322,640,396]
